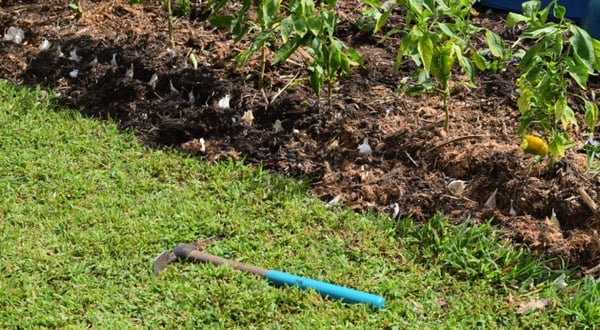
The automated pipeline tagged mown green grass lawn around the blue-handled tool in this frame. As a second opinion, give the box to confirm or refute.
[0,82,600,329]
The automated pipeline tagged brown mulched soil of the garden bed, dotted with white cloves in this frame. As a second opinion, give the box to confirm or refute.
[0,0,600,269]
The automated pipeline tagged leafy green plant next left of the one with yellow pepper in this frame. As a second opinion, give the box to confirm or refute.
[368,0,507,130]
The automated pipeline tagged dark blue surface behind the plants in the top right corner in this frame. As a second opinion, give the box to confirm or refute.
[480,0,600,39]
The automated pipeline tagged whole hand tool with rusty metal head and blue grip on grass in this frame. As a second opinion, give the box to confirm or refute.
[154,238,385,309]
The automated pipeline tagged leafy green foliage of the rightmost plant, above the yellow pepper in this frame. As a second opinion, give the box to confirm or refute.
[507,0,600,168]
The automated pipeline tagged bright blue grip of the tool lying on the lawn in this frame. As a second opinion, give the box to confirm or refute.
[265,270,385,309]
